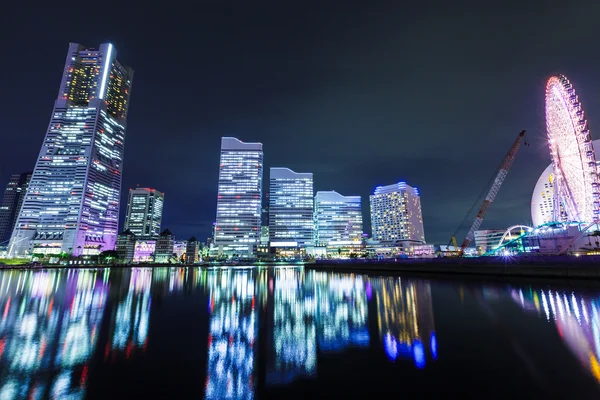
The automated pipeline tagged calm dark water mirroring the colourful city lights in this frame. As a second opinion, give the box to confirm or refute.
[0,267,600,399]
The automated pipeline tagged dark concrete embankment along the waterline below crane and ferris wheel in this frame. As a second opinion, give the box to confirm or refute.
[305,257,600,280]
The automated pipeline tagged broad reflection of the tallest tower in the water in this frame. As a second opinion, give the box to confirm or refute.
[0,269,109,399]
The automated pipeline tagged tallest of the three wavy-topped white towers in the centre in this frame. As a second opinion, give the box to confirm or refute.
[214,137,263,256]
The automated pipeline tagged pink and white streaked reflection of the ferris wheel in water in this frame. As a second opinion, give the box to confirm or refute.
[510,287,600,382]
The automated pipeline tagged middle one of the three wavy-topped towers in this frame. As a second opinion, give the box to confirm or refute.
[269,168,314,251]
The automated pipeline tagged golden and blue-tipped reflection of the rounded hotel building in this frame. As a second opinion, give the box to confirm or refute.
[370,277,437,368]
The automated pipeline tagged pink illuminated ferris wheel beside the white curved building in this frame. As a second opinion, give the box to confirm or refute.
[546,75,600,223]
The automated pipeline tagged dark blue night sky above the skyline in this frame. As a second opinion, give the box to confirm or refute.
[0,0,600,243]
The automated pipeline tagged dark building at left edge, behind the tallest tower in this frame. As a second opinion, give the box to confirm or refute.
[0,172,31,243]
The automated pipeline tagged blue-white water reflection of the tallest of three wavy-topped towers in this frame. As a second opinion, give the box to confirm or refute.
[206,269,258,399]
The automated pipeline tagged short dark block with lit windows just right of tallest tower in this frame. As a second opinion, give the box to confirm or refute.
[125,188,165,238]
